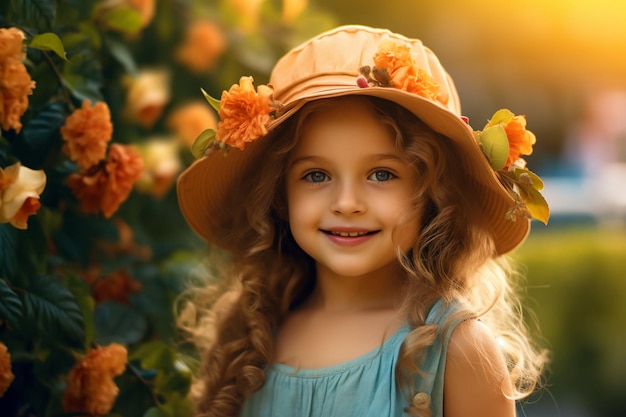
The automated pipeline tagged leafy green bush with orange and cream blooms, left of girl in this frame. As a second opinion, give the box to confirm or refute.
[0,0,334,417]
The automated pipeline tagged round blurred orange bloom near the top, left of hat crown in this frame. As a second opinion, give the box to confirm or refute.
[176,20,226,73]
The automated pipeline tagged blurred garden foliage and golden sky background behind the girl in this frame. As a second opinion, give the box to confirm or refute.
[0,0,626,417]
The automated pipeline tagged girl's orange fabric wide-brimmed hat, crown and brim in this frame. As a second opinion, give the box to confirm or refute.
[177,26,534,254]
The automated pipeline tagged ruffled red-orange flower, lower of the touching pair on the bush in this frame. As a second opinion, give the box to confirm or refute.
[67,143,143,218]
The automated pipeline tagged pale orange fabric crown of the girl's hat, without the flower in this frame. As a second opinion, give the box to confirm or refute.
[270,25,461,115]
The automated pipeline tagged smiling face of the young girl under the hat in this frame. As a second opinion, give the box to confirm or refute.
[286,100,421,276]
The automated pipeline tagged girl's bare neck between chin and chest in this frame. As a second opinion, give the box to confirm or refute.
[305,264,406,313]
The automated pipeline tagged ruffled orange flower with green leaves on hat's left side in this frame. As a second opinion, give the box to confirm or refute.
[192,76,279,157]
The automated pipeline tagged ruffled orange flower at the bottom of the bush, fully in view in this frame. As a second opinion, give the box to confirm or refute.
[63,343,128,416]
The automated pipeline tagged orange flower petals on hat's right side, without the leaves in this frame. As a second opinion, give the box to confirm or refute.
[485,109,537,169]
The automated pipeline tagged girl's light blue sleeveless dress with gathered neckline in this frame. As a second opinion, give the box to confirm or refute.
[241,300,460,417]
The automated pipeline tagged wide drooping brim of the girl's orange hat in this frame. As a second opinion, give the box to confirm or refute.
[177,86,530,254]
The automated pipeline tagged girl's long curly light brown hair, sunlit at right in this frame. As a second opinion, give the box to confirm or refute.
[181,97,545,417]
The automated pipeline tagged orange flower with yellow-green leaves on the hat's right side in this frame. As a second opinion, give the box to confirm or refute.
[474,109,550,224]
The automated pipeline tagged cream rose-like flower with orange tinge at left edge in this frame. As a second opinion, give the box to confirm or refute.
[0,162,46,229]
